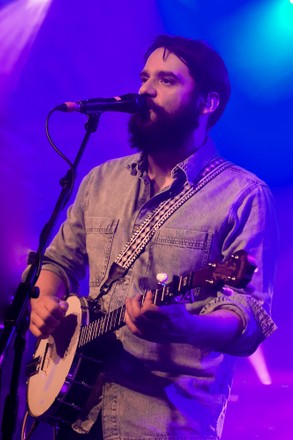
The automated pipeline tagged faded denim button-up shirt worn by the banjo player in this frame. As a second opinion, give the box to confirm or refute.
[44,140,277,440]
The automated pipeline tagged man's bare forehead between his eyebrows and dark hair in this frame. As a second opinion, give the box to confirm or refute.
[143,47,193,80]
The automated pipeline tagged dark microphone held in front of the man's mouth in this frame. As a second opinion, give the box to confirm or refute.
[55,93,147,115]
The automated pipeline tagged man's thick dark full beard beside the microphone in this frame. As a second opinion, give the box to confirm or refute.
[128,94,200,154]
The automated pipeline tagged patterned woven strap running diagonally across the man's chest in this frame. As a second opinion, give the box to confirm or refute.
[96,157,232,300]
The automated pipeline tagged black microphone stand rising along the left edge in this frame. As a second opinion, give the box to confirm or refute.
[0,113,101,440]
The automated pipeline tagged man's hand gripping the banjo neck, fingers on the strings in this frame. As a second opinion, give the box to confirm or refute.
[125,292,197,343]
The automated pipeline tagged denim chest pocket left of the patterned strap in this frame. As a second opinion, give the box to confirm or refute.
[85,217,118,295]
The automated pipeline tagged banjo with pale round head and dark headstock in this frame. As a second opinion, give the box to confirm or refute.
[26,250,256,425]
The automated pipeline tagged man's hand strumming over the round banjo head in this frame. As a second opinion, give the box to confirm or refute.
[29,295,68,339]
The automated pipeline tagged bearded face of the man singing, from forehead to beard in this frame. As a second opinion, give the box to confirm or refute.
[129,48,199,152]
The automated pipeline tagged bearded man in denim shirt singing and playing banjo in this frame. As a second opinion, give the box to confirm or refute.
[30,36,277,440]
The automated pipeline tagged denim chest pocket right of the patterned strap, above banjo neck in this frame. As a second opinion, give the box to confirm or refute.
[144,228,212,288]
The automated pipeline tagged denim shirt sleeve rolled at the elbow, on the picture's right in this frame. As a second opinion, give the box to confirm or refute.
[200,181,278,356]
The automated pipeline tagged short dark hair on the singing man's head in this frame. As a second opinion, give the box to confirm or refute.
[145,35,230,126]
